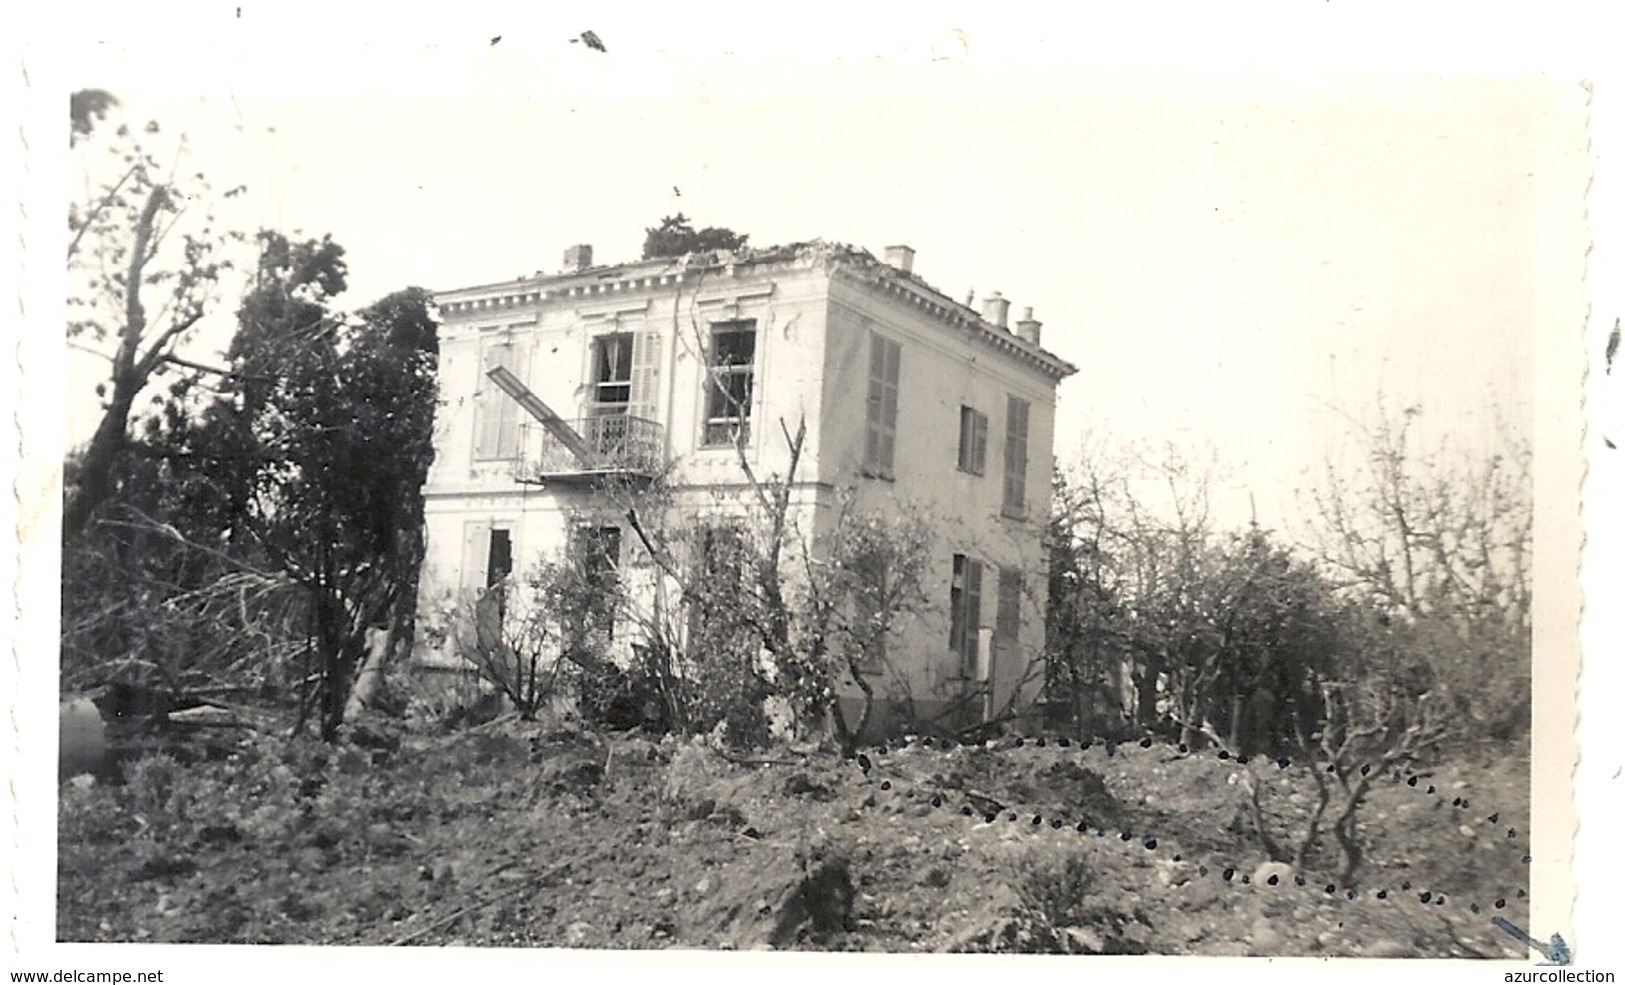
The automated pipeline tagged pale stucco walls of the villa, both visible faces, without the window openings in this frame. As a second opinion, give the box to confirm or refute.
[419,247,1055,737]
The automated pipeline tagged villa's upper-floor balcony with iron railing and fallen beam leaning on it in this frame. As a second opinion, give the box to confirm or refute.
[515,414,666,484]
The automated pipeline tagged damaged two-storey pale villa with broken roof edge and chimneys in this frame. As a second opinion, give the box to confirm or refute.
[414,242,1074,730]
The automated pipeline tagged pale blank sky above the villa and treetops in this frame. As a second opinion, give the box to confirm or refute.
[72,19,1584,536]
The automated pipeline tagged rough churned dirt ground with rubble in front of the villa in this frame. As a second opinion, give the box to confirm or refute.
[57,718,1529,957]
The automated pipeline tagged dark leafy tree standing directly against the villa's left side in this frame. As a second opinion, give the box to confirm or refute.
[177,232,437,738]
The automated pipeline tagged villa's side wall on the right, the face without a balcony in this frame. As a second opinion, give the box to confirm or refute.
[821,276,1055,728]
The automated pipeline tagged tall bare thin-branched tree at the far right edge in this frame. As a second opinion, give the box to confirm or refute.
[1311,400,1534,738]
